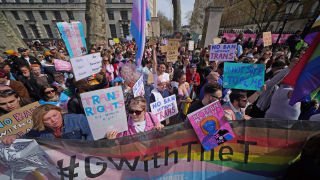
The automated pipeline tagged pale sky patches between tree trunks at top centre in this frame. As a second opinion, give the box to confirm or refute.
[157,0,195,25]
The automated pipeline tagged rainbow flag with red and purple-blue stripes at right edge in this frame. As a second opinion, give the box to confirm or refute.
[283,32,320,105]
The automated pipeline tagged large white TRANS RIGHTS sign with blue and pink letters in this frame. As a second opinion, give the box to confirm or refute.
[80,86,128,140]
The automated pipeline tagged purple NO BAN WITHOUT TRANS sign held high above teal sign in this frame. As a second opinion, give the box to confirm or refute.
[209,44,237,61]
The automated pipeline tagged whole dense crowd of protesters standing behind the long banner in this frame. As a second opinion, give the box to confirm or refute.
[0,31,319,144]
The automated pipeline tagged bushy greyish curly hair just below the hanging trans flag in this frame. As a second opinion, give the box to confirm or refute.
[120,63,141,84]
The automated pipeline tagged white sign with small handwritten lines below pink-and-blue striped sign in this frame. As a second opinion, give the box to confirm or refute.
[70,53,102,81]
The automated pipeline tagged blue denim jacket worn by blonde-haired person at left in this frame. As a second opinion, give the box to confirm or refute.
[24,114,93,140]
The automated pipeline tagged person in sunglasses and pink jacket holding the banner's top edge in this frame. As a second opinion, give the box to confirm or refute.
[107,96,164,139]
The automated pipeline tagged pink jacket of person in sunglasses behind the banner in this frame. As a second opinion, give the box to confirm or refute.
[117,112,160,138]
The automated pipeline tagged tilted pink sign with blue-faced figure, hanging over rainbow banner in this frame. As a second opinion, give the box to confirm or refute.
[188,101,235,151]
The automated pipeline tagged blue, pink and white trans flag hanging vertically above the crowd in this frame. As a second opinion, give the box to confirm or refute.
[130,0,151,68]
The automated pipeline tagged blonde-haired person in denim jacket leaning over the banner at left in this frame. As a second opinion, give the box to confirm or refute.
[2,104,93,145]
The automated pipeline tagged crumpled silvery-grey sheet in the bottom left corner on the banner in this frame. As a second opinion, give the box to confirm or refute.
[0,139,59,179]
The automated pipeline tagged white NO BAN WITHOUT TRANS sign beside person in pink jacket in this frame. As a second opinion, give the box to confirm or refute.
[150,95,178,121]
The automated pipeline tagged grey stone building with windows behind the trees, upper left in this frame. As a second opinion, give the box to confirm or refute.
[0,0,160,40]
